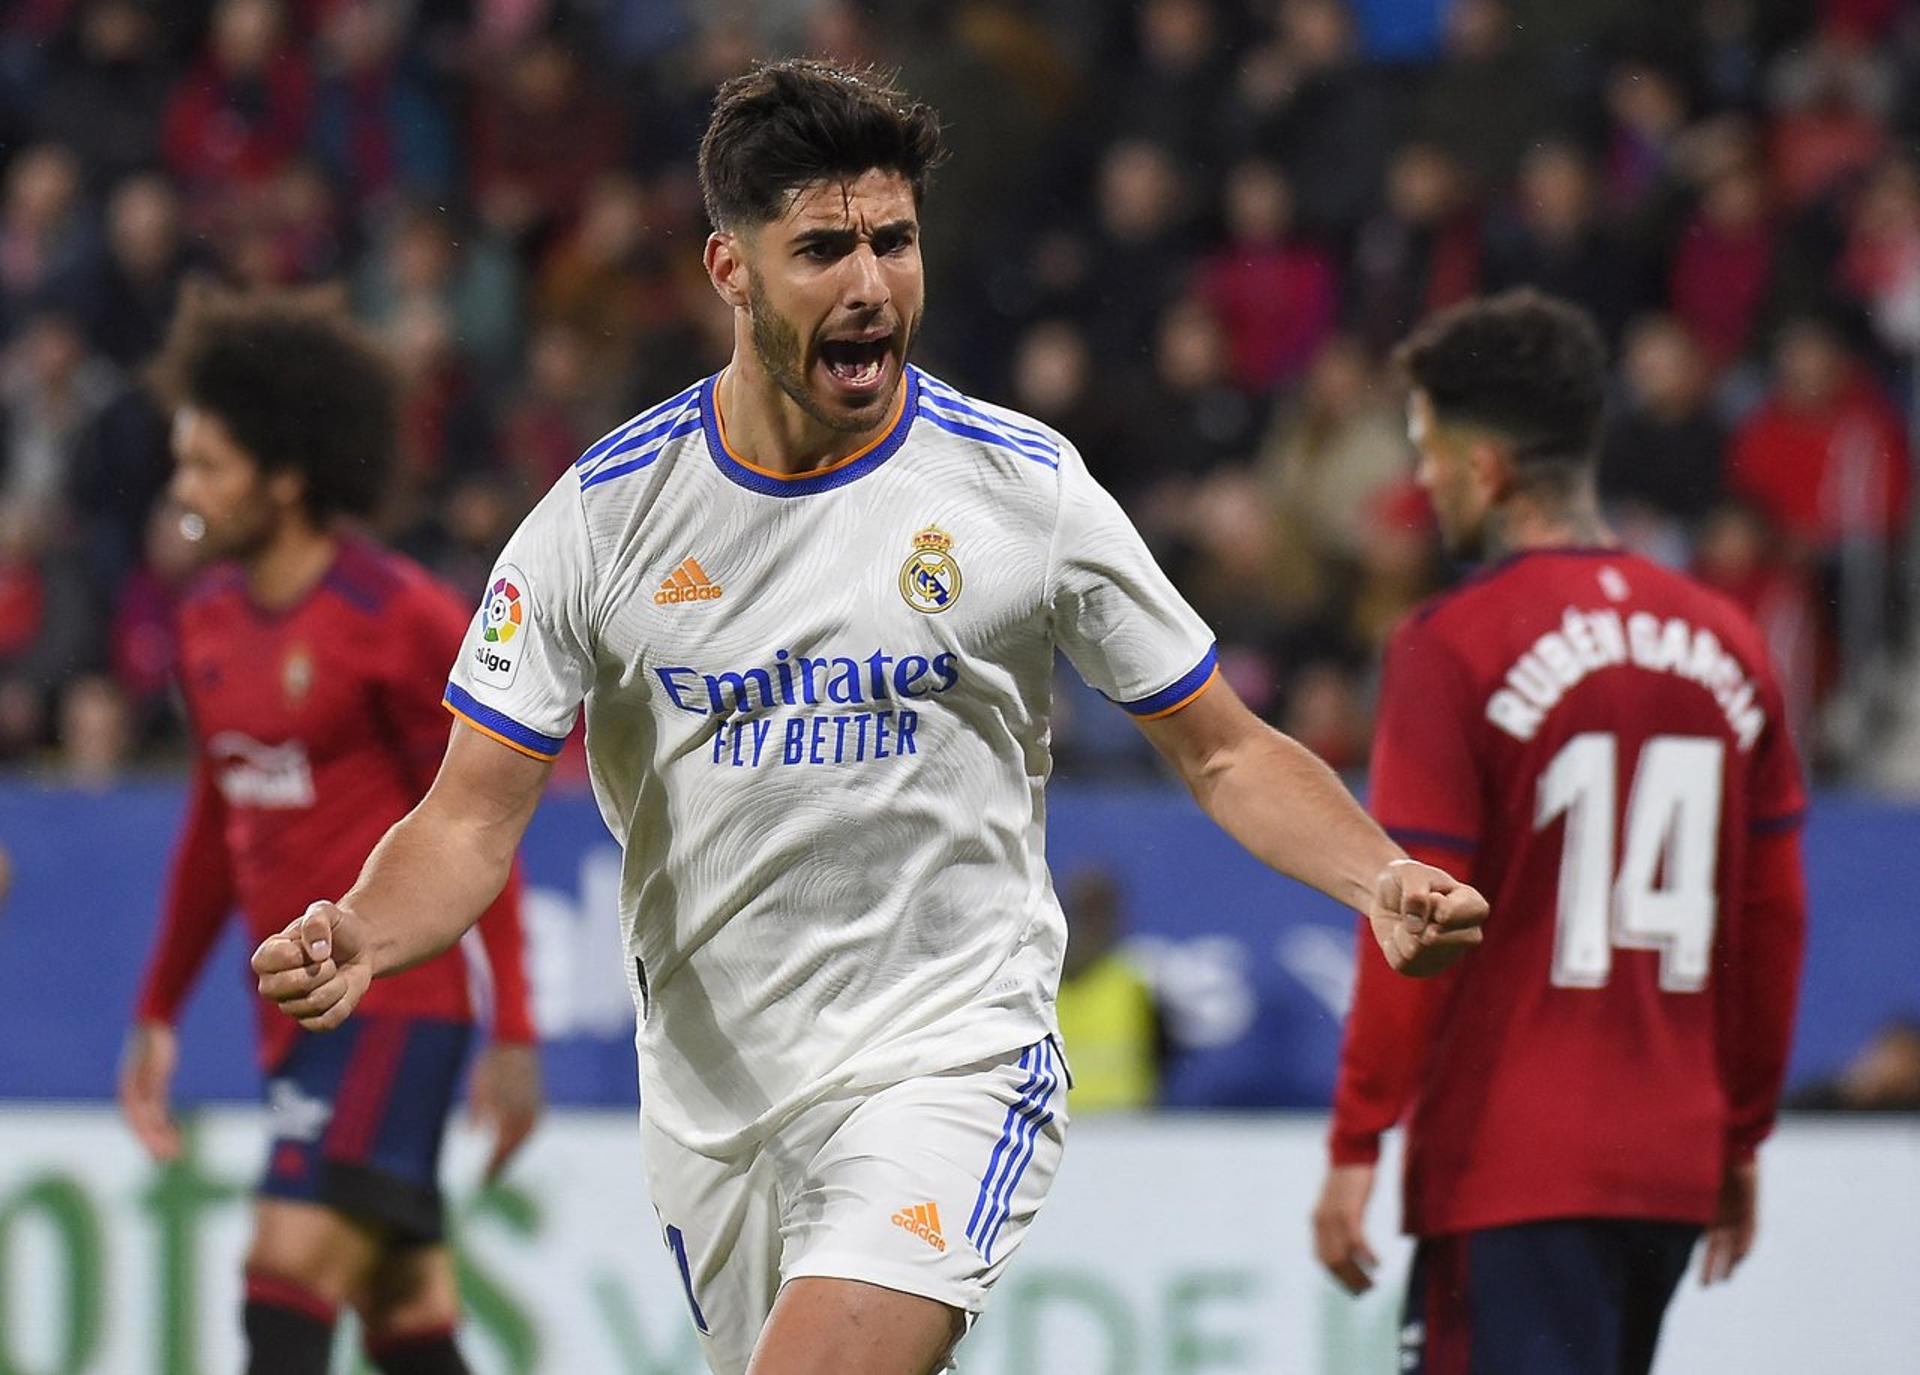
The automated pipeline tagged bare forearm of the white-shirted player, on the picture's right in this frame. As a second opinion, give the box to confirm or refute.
[1187,726,1405,912]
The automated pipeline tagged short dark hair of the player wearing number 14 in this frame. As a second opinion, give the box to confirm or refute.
[1394,286,1607,470]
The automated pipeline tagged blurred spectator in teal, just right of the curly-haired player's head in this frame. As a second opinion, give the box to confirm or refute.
[353,205,520,376]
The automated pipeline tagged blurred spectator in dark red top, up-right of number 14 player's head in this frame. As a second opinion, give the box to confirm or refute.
[1667,163,1774,374]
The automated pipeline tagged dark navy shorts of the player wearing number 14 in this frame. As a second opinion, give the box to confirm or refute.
[1400,1218,1701,1375]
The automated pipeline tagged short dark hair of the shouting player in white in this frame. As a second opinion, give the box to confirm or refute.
[701,58,947,230]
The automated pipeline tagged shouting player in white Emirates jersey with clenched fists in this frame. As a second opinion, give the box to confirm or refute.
[253,61,1484,1375]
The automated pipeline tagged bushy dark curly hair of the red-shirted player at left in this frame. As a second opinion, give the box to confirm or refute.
[154,290,399,522]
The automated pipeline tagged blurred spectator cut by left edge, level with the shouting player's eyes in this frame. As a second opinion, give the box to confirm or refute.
[0,144,98,342]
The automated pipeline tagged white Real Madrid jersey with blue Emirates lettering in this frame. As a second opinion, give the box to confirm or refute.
[447,369,1215,1154]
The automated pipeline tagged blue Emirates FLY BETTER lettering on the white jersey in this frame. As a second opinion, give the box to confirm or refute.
[653,649,960,768]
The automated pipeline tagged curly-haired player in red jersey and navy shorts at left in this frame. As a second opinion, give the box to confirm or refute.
[121,298,540,1375]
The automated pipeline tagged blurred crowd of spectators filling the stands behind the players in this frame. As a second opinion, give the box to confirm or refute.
[0,0,1920,780]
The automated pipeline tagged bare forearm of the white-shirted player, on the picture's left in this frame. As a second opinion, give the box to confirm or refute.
[340,799,515,977]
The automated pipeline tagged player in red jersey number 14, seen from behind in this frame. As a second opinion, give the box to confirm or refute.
[1313,292,1805,1375]
